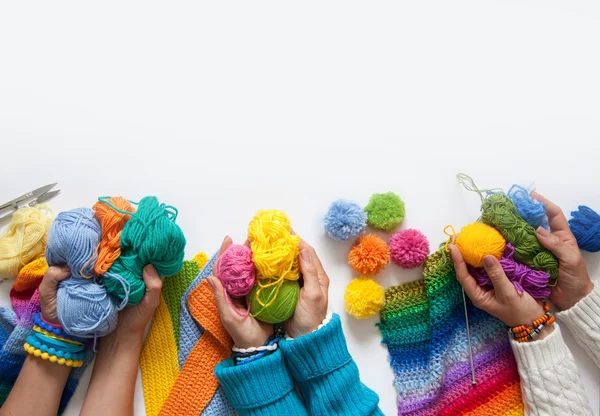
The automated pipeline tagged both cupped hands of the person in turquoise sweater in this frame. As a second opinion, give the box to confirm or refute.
[208,237,329,348]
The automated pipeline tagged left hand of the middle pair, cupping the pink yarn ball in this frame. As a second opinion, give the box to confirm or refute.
[207,236,273,348]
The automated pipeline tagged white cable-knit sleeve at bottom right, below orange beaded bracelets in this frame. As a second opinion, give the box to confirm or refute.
[511,324,593,416]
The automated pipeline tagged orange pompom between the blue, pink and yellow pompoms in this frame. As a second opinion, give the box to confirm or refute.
[348,234,390,275]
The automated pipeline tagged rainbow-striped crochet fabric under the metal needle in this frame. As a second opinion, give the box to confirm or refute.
[378,249,524,416]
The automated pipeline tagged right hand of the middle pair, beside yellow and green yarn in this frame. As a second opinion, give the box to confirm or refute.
[284,240,329,338]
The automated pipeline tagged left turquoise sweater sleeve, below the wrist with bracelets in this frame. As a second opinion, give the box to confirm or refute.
[215,350,308,416]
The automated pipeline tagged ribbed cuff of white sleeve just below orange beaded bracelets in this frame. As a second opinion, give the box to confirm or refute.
[509,324,573,374]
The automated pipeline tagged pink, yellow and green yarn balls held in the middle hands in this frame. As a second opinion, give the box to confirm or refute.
[215,210,300,324]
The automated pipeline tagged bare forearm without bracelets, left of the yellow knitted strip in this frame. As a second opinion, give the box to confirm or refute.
[81,330,143,416]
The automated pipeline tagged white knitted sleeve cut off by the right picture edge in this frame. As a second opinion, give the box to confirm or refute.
[556,287,600,368]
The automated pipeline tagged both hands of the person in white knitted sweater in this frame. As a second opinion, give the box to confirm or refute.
[450,192,594,339]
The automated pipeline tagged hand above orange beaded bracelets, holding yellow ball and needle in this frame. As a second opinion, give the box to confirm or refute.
[450,246,549,330]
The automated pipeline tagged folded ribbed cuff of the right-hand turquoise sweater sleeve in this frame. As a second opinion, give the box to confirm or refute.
[279,314,352,382]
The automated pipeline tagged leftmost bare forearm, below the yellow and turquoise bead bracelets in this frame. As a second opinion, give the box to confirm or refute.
[0,355,71,416]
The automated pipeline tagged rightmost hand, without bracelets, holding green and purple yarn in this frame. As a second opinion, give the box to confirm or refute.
[531,192,594,311]
